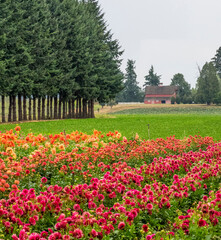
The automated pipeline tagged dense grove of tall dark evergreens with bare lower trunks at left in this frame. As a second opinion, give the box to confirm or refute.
[0,0,123,122]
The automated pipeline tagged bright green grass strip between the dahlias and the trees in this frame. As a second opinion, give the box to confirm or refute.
[0,114,221,140]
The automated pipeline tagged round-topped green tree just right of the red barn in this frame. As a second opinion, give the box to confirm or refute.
[170,73,191,103]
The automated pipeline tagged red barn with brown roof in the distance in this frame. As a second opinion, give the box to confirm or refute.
[144,86,178,104]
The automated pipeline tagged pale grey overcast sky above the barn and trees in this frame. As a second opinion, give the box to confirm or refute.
[99,0,221,87]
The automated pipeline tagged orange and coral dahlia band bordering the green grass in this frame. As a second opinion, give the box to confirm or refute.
[0,127,216,196]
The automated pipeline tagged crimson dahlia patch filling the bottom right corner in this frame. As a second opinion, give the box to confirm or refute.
[155,188,221,240]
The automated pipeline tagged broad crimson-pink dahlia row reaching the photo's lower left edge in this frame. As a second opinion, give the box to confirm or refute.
[0,156,218,239]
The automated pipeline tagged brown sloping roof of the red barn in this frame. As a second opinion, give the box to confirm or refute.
[145,86,178,95]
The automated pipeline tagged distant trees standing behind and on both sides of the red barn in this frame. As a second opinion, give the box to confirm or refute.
[116,47,221,105]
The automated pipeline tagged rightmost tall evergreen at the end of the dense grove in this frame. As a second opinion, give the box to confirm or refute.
[77,0,123,117]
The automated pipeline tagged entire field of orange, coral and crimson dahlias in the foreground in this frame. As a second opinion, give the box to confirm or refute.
[0,126,221,240]
